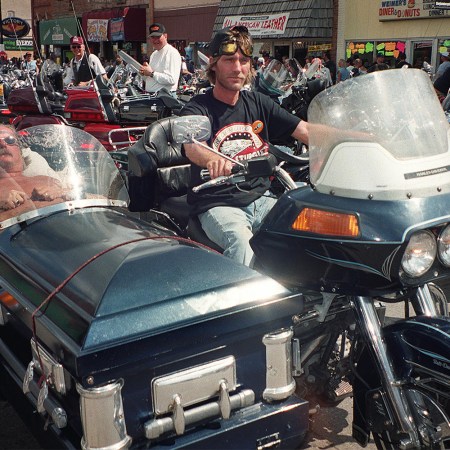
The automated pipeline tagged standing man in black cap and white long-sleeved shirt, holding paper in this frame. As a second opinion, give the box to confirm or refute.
[140,23,181,95]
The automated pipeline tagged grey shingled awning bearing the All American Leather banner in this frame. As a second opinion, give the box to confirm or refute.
[213,0,333,40]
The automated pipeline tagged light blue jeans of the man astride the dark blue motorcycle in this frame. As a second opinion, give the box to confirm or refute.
[198,193,277,266]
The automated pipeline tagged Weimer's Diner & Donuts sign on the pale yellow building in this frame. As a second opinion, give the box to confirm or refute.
[378,0,450,22]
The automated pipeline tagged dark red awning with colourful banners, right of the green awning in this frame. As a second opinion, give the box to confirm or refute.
[82,7,147,42]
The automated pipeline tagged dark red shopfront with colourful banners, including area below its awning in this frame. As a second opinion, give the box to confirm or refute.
[82,7,147,60]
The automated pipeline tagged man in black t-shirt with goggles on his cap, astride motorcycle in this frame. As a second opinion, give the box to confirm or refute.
[181,26,309,265]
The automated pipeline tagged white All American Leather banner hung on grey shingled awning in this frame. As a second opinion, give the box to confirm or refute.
[223,13,289,36]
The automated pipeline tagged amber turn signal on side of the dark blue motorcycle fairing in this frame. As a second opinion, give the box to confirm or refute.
[292,208,359,237]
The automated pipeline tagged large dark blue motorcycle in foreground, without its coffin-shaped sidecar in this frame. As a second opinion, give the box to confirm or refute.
[125,69,450,450]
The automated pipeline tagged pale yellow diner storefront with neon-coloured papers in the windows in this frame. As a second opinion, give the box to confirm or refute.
[341,0,450,71]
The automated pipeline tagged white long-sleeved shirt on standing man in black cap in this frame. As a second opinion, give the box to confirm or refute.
[143,44,181,92]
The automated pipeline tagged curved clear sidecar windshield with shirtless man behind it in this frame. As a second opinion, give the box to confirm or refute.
[0,125,129,229]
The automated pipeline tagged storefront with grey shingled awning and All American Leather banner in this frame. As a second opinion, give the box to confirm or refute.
[214,0,333,64]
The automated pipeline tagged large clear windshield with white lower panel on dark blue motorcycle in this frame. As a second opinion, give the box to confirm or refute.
[308,69,450,200]
